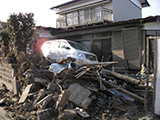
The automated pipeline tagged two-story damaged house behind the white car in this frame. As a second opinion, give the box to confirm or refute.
[48,0,160,70]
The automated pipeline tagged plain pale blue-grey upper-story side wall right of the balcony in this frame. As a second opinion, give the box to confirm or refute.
[112,0,142,22]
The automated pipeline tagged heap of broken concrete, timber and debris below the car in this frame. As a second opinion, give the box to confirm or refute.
[0,58,158,120]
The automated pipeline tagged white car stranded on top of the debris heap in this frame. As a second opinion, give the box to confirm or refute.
[41,39,97,63]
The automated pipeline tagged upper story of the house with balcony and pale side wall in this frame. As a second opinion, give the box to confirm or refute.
[51,0,149,28]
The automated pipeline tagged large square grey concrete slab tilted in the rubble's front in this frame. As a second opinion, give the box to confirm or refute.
[68,83,92,109]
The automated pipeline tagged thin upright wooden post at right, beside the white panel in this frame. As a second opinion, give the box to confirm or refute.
[144,37,149,113]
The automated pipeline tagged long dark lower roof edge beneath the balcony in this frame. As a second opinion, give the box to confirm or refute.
[52,16,160,34]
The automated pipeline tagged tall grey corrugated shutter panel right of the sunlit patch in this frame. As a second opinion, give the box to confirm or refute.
[122,28,140,69]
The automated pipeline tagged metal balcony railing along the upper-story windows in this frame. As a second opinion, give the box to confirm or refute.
[56,7,113,28]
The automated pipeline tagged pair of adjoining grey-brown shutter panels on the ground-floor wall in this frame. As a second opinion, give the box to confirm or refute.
[113,28,140,69]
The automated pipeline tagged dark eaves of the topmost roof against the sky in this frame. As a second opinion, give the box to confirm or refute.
[50,0,150,10]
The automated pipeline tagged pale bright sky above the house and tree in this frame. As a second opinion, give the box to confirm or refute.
[0,0,160,27]
